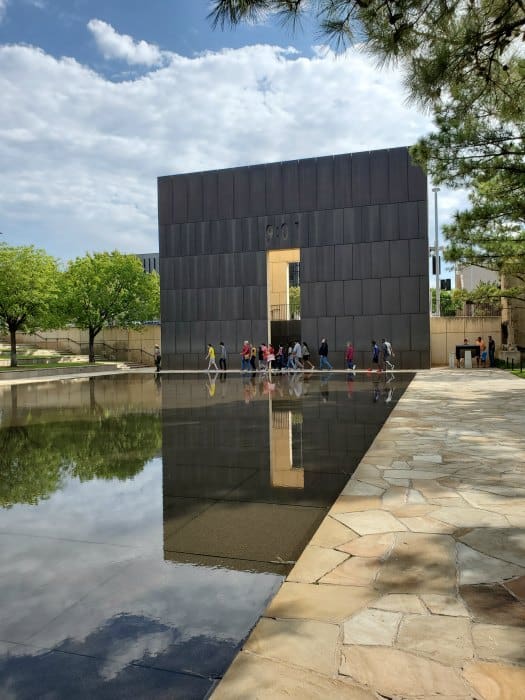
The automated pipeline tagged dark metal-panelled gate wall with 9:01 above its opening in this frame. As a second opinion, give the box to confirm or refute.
[158,148,430,369]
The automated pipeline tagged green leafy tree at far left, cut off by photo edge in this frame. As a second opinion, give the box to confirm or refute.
[0,243,60,367]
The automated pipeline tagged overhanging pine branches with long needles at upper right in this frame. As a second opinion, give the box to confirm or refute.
[210,0,525,290]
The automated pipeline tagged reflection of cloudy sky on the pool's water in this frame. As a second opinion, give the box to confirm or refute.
[0,458,281,699]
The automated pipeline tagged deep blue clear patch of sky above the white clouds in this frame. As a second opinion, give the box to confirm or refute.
[0,0,318,80]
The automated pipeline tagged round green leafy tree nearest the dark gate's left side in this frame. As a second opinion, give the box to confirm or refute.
[63,251,160,362]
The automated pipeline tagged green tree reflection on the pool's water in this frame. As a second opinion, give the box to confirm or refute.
[0,413,162,507]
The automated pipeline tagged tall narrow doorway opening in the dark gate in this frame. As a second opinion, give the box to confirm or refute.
[267,248,301,350]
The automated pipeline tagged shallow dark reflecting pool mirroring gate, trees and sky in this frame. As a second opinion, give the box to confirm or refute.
[0,373,411,700]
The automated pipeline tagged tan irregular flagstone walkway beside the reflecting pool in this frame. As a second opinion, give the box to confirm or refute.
[213,370,525,700]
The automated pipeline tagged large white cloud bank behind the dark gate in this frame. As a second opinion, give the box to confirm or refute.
[0,36,460,258]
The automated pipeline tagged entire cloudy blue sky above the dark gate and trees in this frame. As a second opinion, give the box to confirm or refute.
[0,0,458,268]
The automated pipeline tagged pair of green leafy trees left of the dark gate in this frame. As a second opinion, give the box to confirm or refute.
[0,243,160,367]
